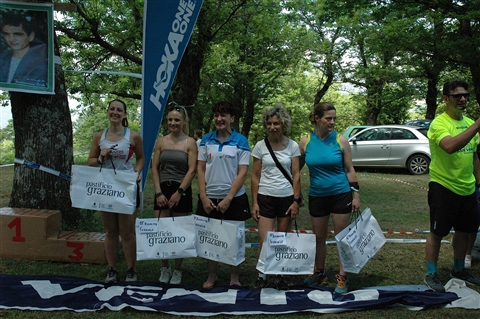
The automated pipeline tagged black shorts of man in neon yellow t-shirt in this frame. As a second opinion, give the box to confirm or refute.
[428,182,479,237]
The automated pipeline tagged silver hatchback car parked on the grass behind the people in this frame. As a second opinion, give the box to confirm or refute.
[348,125,431,175]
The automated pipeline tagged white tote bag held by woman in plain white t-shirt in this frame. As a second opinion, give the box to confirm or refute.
[257,231,316,275]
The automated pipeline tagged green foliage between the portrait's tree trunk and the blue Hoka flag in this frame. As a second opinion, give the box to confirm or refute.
[55,0,143,99]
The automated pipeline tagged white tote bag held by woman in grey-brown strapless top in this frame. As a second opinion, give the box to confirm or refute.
[135,215,197,260]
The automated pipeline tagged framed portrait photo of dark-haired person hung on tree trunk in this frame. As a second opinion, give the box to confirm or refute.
[0,0,55,94]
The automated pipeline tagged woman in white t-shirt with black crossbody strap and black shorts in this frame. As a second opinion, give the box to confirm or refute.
[251,107,301,289]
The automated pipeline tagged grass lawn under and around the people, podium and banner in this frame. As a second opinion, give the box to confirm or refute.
[0,167,480,319]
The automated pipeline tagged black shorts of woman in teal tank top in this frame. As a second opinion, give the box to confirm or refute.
[308,192,353,217]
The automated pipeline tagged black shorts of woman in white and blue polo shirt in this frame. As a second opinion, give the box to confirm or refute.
[197,193,252,221]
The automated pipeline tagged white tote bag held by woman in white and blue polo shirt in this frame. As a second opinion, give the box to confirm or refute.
[194,215,245,266]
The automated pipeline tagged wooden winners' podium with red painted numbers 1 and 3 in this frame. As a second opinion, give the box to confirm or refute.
[0,207,107,264]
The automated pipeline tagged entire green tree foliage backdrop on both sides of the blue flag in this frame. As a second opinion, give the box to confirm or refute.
[55,0,480,144]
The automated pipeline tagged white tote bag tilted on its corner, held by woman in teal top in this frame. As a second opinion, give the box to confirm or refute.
[335,208,386,274]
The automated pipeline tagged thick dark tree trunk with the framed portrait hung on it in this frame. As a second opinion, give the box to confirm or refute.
[9,31,80,225]
